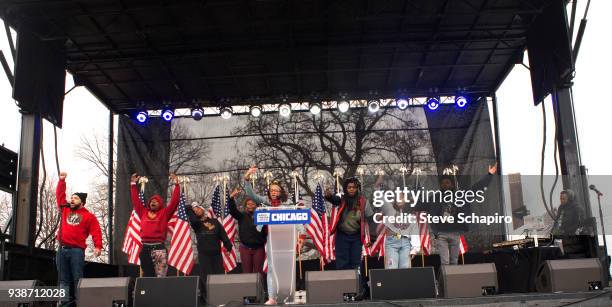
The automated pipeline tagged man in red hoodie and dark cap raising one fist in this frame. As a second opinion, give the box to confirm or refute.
[55,172,102,306]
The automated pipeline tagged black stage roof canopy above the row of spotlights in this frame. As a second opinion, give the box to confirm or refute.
[0,0,549,113]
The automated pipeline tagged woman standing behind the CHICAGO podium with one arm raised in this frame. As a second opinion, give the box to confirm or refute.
[244,165,291,305]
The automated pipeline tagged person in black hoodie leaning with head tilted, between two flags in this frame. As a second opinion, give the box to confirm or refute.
[186,204,232,300]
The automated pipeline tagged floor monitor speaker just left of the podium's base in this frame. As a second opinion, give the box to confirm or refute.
[206,273,264,306]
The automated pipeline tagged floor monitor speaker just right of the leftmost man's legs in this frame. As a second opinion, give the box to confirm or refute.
[77,277,134,307]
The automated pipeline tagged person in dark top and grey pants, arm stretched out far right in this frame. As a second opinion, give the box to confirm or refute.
[416,163,497,265]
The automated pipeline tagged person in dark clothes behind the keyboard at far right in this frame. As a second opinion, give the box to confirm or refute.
[552,189,586,258]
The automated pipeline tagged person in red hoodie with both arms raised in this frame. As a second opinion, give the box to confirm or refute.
[131,174,181,277]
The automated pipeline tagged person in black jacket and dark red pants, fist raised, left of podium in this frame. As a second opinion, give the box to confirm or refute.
[229,189,267,274]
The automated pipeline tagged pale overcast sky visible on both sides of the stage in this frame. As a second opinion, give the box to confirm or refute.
[0,1,612,190]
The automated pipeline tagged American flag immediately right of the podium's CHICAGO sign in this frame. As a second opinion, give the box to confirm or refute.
[306,184,332,264]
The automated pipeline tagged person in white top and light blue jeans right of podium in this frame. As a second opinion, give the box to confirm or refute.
[382,195,421,269]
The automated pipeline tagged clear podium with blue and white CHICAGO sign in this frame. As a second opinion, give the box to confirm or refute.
[254,206,310,303]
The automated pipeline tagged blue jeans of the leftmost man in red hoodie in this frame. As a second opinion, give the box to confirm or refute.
[55,247,85,301]
